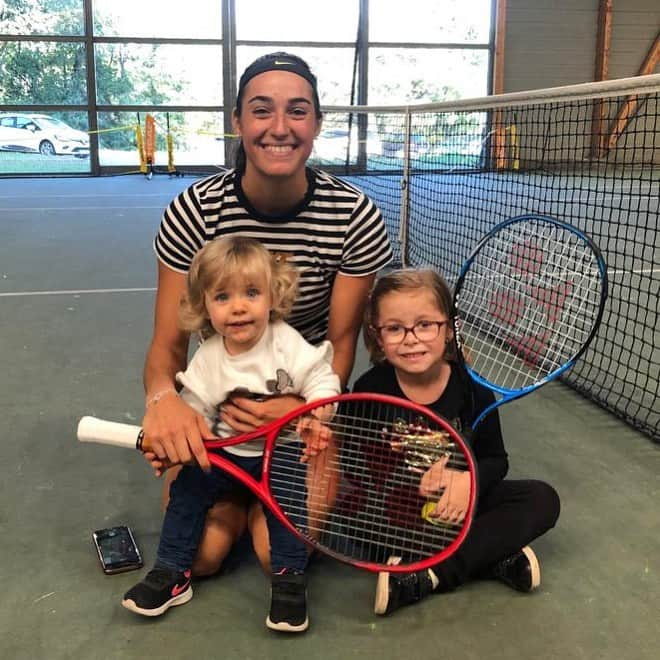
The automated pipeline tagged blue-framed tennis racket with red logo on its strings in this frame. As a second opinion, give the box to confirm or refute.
[454,215,607,429]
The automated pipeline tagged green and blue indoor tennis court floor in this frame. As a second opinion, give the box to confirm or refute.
[0,176,660,660]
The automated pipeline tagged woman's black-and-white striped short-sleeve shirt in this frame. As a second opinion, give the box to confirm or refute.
[154,168,392,344]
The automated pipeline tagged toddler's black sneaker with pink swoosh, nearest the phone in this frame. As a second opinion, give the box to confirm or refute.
[121,567,192,616]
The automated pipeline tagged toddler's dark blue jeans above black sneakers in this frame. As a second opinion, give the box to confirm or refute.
[156,444,308,573]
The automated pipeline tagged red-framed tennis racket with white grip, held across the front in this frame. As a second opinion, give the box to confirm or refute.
[78,393,477,573]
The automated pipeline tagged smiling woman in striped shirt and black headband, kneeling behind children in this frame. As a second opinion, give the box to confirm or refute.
[143,52,391,575]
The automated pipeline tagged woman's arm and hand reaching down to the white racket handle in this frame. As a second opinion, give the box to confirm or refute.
[142,262,212,470]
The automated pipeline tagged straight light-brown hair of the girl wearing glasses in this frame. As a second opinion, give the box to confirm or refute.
[362,268,456,364]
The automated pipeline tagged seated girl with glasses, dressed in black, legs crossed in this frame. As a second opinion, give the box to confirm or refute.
[353,269,559,614]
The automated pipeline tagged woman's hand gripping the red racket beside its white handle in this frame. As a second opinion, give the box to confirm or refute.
[142,391,214,475]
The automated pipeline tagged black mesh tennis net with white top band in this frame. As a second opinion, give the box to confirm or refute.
[315,75,660,442]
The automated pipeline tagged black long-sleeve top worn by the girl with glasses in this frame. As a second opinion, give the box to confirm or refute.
[353,362,509,495]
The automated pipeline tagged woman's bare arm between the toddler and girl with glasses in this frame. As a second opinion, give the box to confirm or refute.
[327,273,376,387]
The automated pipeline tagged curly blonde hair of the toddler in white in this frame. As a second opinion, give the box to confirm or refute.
[179,236,298,337]
